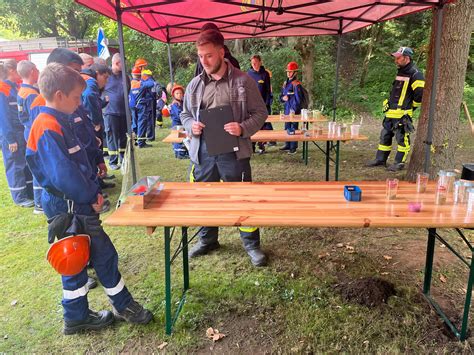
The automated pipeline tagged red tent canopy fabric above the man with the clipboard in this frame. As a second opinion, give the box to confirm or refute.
[76,0,449,43]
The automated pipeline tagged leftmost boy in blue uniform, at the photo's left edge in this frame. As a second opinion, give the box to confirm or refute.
[0,59,34,207]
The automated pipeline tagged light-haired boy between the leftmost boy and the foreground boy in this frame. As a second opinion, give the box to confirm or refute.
[17,60,43,214]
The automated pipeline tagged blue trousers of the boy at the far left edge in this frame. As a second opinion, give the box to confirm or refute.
[0,131,33,204]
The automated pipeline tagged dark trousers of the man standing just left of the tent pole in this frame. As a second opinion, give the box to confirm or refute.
[104,115,127,165]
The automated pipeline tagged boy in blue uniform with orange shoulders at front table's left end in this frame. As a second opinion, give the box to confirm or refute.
[26,63,153,334]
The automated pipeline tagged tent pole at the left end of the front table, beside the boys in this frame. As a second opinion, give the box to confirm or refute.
[115,1,137,184]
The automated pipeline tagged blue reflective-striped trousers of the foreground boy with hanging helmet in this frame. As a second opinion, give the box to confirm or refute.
[61,216,132,321]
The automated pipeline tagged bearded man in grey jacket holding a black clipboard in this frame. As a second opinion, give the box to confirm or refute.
[181,30,268,266]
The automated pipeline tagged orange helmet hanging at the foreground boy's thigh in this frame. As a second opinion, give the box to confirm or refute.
[46,234,90,276]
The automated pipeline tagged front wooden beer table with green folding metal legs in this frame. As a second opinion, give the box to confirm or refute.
[105,181,474,340]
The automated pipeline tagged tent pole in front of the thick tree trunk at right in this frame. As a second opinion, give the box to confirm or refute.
[423,1,444,173]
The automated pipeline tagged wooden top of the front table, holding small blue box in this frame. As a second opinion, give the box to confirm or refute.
[105,181,474,228]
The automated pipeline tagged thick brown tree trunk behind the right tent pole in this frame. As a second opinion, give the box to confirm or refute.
[407,0,474,181]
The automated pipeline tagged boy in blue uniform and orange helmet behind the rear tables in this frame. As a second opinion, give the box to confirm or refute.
[280,62,301,154]
